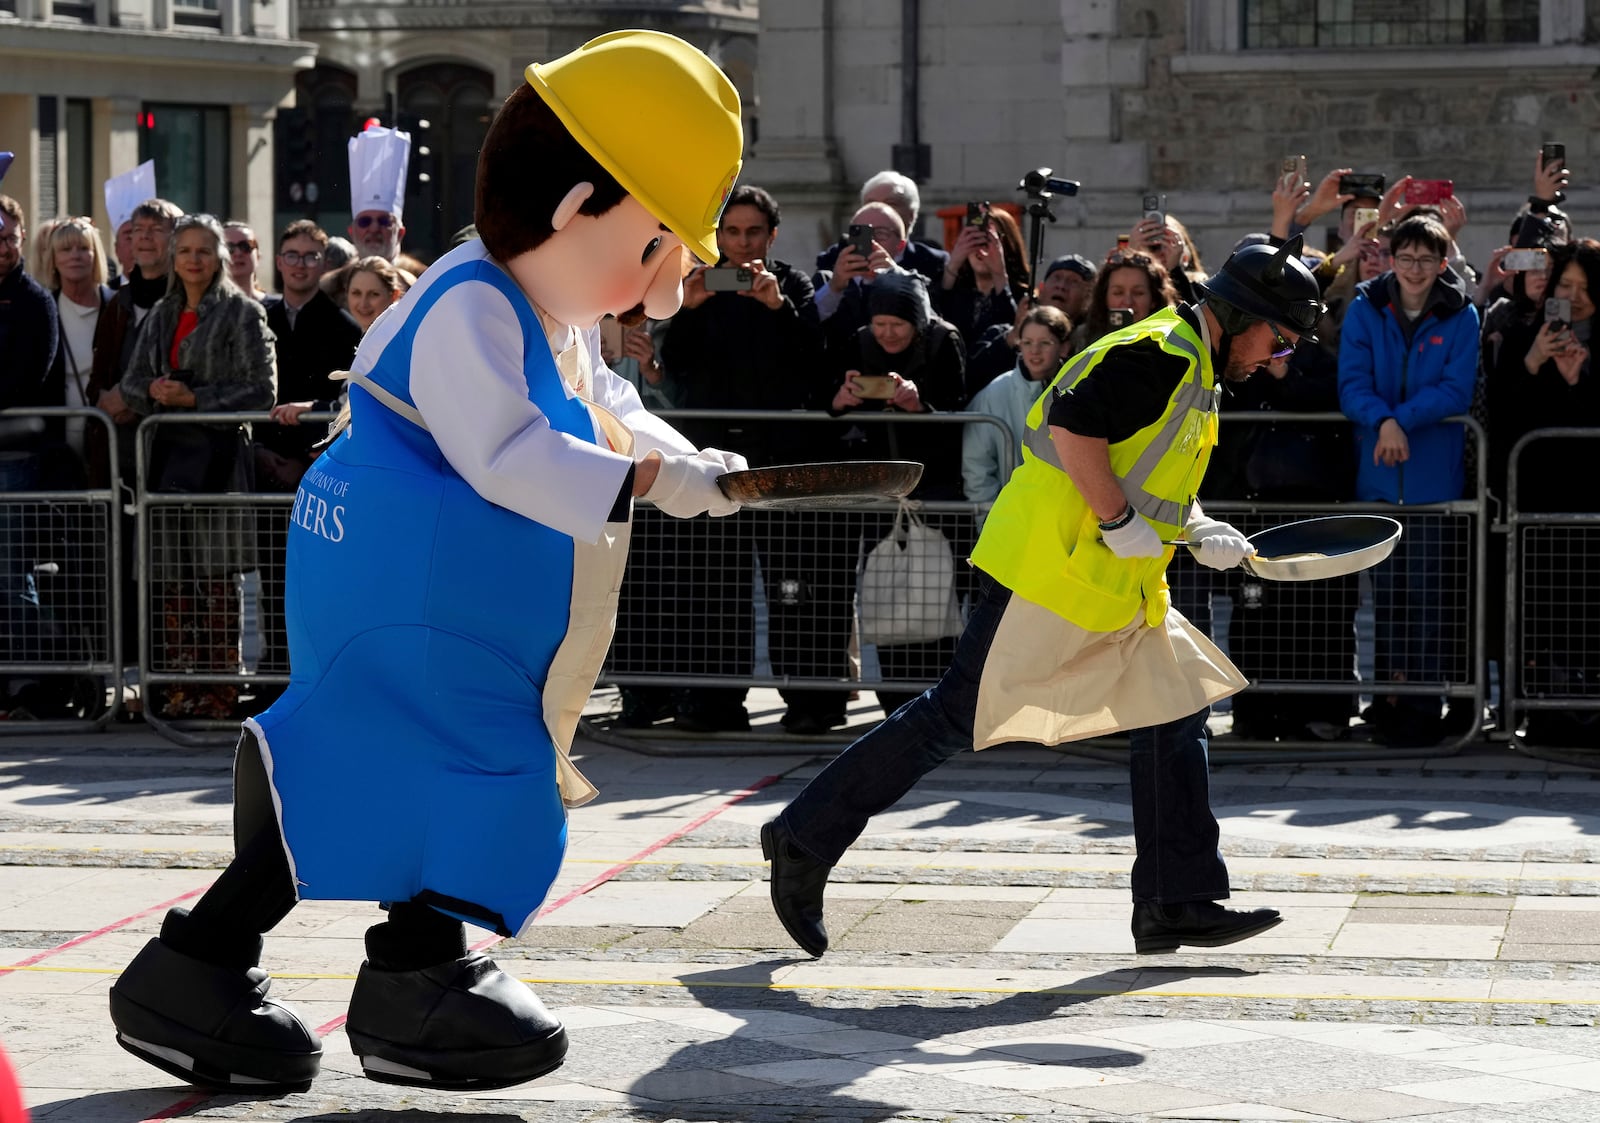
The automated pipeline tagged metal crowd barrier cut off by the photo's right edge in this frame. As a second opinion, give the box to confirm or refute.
[1501,427,1600,763]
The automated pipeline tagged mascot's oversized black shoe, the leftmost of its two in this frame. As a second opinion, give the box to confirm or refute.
[110,909,322,1094]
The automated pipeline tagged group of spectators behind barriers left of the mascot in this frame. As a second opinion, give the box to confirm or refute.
[0,195,424,720]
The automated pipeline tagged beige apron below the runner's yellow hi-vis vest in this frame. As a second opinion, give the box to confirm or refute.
[973,595,1250,749]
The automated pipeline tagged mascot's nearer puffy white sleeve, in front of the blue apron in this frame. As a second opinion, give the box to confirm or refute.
[411,282,632,542]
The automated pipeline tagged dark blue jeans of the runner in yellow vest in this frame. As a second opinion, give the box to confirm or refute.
[779,573,1229,904]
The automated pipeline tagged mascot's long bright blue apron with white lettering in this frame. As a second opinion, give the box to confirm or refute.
[254,261,598,934]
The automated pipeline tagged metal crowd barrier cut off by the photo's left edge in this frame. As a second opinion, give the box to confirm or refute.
[0,406,123,734]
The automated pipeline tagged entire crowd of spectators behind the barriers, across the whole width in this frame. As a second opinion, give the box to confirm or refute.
[0,157,1600,744]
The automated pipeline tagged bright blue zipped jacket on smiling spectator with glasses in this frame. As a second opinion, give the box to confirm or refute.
[1339,267,1478,502]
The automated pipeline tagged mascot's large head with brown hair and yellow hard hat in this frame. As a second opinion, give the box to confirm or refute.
[475,30,744,328]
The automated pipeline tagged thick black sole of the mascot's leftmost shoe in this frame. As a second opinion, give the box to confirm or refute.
[110,989,322,1096]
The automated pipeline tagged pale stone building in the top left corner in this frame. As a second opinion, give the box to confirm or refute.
[0,0,314,262]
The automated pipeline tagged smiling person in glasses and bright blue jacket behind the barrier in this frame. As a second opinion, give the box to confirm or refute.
[1339,216,1478,747]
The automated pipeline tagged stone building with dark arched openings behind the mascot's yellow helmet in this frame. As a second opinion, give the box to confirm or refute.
[292,0,757,259]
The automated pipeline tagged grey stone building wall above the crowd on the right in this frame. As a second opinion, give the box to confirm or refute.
[742,0,1600,266]
